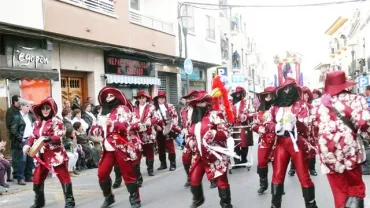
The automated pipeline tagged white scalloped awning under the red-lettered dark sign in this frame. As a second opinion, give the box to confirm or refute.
[105,74,161,85]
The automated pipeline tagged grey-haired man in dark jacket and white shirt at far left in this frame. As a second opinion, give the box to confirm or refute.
[10,99,34,185]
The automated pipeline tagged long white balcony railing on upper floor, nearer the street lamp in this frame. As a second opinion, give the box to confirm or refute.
[129,11,174,35]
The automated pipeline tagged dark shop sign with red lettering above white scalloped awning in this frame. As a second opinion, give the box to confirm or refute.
[105,56,155,77]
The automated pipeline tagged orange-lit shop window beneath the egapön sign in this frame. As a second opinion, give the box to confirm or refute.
[20,79,51,104]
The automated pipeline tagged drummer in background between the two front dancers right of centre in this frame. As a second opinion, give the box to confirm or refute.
[231,86,255,167]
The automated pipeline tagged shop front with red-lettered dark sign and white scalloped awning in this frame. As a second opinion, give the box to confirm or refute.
[104,52,161,101]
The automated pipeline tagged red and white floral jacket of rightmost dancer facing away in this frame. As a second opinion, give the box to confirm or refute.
[311,93,370,174]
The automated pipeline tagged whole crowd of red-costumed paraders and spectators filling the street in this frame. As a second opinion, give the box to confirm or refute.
[0,71,370,208]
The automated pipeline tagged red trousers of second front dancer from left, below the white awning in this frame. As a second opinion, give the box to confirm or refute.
[98,150,136,184]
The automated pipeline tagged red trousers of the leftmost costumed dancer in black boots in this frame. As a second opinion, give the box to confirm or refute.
[33,162,72,185]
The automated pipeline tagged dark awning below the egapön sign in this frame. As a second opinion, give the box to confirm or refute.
[0,67,59,81]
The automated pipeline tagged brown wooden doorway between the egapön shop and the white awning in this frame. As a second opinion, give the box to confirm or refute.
[61,71,87,110]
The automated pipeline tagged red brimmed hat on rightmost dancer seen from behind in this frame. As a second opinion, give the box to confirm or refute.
[324,71,357,96]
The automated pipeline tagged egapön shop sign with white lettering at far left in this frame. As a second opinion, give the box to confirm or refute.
[7,46,51,69]
